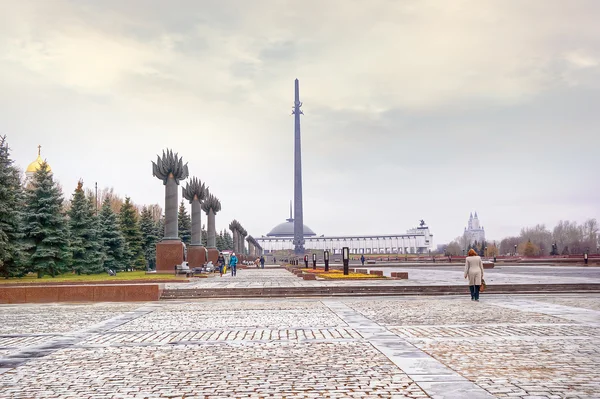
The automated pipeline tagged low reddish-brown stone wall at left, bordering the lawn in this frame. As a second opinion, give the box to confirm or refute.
[0,284,164,304]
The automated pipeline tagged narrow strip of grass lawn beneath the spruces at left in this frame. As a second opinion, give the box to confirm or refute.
[0,271,185,284]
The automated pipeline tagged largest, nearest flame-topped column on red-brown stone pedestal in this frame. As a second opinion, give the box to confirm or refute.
[152,149,189,273]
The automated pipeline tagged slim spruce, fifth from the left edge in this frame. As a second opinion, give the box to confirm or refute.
[119,197,146,270]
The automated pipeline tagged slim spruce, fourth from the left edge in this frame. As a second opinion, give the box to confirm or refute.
[98,197,125,272]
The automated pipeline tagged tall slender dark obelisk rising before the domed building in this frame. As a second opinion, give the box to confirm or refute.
[293,79,304,255]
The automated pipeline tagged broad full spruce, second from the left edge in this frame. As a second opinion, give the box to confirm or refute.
[23,162,70,278]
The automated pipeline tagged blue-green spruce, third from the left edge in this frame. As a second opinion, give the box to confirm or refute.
[69,181,104,274]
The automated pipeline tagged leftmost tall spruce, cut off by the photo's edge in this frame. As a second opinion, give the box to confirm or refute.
[0,136,25,278]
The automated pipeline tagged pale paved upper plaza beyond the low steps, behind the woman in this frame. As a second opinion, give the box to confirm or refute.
[166,266,600,289]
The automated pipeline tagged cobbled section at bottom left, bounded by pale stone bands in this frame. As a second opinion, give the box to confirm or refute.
[0,342,428,398]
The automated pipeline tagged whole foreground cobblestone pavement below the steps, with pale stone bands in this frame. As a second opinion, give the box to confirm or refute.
[0,295,600,399]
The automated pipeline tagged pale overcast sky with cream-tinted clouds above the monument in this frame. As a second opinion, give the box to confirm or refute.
[0,0,600,244]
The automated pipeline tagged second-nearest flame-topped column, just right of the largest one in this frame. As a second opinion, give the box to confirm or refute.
[183,177,208,267]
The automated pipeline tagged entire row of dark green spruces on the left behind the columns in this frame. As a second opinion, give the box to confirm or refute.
[0,136,233,278]
